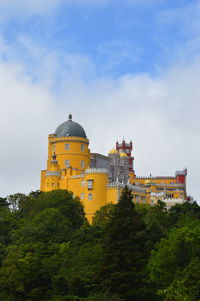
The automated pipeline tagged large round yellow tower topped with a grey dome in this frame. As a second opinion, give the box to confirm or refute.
[41,114,90,191]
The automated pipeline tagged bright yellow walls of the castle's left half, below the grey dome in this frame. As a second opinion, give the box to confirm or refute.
[41,114,146,221]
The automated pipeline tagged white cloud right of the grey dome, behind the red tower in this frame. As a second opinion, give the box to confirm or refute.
[57,60,200,199]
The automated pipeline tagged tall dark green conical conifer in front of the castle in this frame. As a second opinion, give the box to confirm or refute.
[99,187,145,301]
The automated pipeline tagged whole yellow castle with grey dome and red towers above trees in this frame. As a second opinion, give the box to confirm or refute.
[41,114,187,221]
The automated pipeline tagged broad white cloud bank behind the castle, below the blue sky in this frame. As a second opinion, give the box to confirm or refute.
[0,37,200,199]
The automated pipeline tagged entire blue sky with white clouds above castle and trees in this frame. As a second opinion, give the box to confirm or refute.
[0,0,200,200]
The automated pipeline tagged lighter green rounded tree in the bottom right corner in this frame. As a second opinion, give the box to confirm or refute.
[148,220,200,300]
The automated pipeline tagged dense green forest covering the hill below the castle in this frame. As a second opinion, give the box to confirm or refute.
[0,188,200,301]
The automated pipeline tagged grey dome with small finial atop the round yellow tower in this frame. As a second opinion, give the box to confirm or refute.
[54,114,87,138]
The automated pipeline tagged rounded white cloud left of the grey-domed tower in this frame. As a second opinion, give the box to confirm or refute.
[0,59,56,194]
